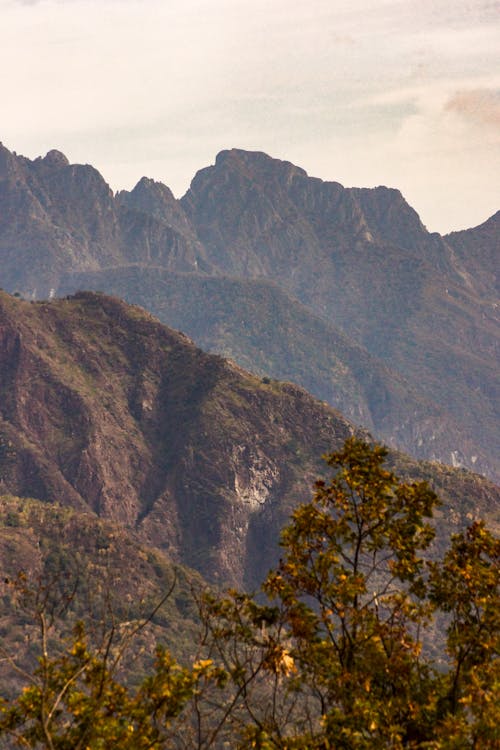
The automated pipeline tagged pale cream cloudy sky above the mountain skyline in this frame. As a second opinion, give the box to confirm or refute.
[0,0,500,233]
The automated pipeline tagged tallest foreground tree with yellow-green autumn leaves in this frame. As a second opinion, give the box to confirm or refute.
[265,440,437,748]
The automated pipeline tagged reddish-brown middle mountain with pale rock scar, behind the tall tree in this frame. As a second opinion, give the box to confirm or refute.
[0,293,500,587]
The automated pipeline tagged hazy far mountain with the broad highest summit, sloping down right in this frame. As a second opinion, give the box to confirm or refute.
[181,150,500,476]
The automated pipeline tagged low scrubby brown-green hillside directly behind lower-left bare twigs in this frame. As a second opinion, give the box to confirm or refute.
[0,495,206,697]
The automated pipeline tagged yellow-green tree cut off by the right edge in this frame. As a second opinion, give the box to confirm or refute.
[430,522,500,748]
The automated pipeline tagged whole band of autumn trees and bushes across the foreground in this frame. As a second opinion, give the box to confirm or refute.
[0,438,500,750]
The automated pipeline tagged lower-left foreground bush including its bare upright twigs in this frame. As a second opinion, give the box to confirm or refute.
[0,574,225,750]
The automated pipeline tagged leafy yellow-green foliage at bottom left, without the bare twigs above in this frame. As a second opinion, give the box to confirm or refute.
[0,625,199,750]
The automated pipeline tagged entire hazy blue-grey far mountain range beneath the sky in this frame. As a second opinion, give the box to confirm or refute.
[0,142,500,481]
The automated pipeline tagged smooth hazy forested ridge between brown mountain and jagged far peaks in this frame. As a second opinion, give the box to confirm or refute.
[61,266,482,468]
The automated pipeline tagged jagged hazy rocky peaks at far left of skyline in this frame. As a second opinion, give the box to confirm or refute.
[0,146,203,299]
